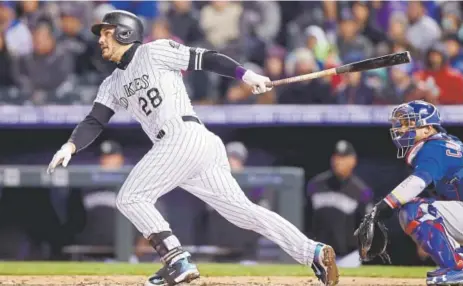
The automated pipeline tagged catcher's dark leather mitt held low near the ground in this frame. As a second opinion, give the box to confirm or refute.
[354,209,391,264]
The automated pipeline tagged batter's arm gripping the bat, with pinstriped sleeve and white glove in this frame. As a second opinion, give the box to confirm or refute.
[147,39,271,94]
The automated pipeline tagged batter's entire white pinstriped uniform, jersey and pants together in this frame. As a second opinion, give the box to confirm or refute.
[99,40,316,265]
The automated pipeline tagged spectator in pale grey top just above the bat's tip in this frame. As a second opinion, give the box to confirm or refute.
[406,1,442,53]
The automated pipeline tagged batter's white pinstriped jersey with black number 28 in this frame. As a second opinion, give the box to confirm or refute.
[94,40,205,140]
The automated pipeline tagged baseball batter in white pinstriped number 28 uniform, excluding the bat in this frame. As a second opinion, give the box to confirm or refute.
[48,10,339,285]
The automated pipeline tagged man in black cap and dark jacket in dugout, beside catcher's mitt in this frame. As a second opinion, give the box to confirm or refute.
[306,140,373,267]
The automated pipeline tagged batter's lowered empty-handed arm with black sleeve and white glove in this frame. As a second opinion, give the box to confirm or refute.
[47,78,118,174]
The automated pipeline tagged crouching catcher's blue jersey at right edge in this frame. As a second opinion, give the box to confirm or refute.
[406,133,463,201]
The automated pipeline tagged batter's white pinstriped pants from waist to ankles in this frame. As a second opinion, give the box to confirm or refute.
[116,116,317,265]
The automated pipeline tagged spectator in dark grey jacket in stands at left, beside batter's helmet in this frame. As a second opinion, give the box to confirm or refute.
[18,17,74,104]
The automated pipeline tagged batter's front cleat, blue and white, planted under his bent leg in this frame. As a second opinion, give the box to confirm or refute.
[145,257,200,286]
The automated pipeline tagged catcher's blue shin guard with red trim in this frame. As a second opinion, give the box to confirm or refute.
[399,201,463,270]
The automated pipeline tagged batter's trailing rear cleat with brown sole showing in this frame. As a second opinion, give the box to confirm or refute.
[312,243,339,286]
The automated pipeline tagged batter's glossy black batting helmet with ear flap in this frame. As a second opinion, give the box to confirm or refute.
[92,10,143,45]
